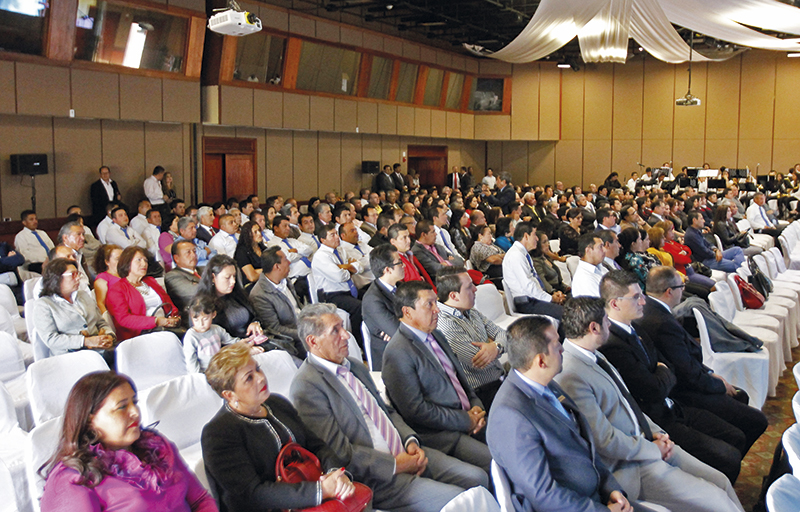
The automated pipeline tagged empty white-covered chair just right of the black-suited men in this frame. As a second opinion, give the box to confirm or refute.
[693,309,769,409]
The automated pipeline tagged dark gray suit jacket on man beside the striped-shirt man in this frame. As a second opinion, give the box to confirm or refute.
[381,322,483,453]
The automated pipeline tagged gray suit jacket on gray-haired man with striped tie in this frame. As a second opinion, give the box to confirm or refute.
[291,357,415,500]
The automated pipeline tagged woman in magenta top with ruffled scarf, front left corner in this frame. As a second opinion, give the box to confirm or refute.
[41,371,217,512]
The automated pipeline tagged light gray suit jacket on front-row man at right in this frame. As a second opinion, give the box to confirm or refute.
[555,343,663,490]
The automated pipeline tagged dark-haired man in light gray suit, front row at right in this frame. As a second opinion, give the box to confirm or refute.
[556,297,743,512]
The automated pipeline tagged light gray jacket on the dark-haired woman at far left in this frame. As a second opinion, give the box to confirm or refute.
[33,290,114,356]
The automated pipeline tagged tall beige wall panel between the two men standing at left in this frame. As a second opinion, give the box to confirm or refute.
[101,120,146,210]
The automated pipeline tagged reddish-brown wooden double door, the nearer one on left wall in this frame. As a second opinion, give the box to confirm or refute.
[203,137,256,203]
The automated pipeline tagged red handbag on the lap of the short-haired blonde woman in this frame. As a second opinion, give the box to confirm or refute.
[275,443,372,512]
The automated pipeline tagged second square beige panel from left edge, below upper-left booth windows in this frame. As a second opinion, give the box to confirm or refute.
[16,62,71,117]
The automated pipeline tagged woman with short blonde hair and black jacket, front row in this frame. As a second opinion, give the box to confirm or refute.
[201,344,354,511]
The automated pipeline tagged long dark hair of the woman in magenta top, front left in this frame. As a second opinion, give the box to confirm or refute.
[39,371,158,487]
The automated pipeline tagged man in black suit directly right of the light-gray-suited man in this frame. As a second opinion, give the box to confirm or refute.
[600,270,745,483]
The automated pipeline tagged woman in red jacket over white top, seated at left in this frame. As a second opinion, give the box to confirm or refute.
[106,246,180,341]
